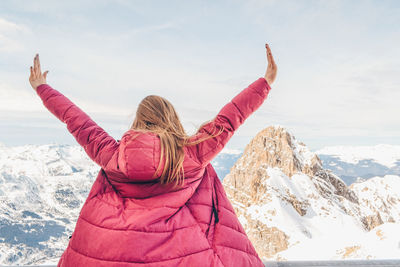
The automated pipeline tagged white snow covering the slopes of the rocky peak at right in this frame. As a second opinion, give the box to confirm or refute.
[228,161,400,260]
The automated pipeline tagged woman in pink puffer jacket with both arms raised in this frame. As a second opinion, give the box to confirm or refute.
[29,44,277,266]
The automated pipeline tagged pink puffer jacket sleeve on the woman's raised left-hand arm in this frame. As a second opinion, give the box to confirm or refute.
[36,84,119,168]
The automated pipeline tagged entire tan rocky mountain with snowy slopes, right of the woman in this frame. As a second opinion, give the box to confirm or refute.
[223,126,400,260]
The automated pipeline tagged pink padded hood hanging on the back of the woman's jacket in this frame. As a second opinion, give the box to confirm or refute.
[118,130,164,182]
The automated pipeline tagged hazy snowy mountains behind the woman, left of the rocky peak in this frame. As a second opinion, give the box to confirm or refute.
[0,143,240,265]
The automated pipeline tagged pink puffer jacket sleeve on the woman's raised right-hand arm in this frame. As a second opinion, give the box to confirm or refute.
[193,77,271,166]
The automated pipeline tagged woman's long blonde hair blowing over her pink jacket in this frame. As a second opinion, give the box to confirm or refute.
[131,95,224,187]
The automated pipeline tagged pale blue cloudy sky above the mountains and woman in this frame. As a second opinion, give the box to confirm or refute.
[0,0,400,150]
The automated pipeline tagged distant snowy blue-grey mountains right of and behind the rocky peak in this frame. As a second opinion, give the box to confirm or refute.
[315,144,400,185]
